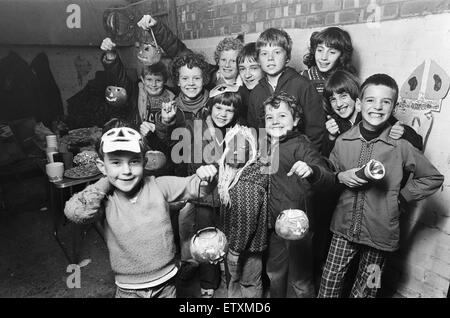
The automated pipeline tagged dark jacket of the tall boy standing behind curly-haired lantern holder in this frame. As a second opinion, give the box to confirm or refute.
[247,67,325,149]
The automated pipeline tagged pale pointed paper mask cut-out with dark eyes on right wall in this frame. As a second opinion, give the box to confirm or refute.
[394,60,450,149]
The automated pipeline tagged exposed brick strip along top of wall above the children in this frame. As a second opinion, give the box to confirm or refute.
[174,0,450,40]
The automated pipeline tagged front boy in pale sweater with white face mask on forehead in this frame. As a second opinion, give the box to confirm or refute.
[64,127,217,298]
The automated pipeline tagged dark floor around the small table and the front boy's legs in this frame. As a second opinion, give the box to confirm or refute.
[0,175,226,298]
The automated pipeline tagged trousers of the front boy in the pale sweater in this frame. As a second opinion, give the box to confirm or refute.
[115,278,177,298]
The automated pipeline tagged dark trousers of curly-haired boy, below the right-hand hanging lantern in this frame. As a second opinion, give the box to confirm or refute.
[267,232,315,298]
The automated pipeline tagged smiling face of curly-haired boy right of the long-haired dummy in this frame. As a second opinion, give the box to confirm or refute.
[265,101,299,137]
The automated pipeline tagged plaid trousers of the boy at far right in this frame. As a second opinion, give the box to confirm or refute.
[317,234,386,298]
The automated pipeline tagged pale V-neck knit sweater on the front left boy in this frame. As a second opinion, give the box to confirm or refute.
[64,175,210,284]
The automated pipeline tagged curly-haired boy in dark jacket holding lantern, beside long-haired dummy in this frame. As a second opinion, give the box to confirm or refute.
[263,92,334,298]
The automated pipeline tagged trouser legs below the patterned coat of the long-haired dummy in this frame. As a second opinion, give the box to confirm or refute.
[227,250,263,298]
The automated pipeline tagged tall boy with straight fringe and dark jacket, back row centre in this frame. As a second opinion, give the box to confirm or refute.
[247,28,325,149]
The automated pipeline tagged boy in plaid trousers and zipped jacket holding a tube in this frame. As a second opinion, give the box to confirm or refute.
[318,74,444,297]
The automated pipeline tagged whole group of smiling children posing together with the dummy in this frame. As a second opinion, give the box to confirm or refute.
[65,15,443,298]
